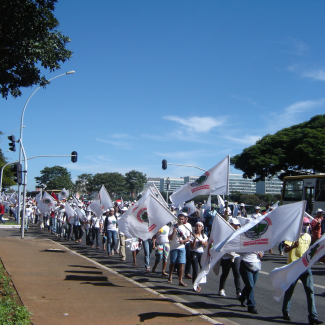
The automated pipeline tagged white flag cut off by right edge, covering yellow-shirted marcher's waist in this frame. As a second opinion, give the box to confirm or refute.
[269,235,325,301]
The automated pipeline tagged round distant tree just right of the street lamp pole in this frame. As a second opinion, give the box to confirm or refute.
[35,166,72,190]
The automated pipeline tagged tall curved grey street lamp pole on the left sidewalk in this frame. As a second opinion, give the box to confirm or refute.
[18,71,75,238]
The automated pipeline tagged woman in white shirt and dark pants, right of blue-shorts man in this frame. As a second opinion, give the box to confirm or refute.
[190,221,208,292]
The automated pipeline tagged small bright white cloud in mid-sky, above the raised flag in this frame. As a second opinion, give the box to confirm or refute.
[164,116,225,133]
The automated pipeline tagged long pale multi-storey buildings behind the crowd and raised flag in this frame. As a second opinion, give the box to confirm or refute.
[145,174,282,195]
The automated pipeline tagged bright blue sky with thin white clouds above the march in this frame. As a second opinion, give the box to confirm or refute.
[0,0,325,190]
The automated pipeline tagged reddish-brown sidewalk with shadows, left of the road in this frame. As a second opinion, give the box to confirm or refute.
[0,233,220,325]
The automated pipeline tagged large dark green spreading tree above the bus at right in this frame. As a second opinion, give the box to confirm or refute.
[231,115,325,181]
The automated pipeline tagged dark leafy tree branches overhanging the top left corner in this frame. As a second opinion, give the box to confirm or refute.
[0,0,72,98]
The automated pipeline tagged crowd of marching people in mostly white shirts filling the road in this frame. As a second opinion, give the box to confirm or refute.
[0,186,325,324]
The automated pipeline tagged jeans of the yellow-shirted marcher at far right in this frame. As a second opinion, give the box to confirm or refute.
[282,269,318,320]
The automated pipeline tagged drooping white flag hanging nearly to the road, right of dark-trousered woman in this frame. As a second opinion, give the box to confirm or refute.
[193,214,235,290]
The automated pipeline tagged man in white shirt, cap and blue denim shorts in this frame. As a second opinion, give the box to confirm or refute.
[168,212,190,287]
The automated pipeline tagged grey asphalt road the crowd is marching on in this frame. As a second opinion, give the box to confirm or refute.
[0,228,325,325]
